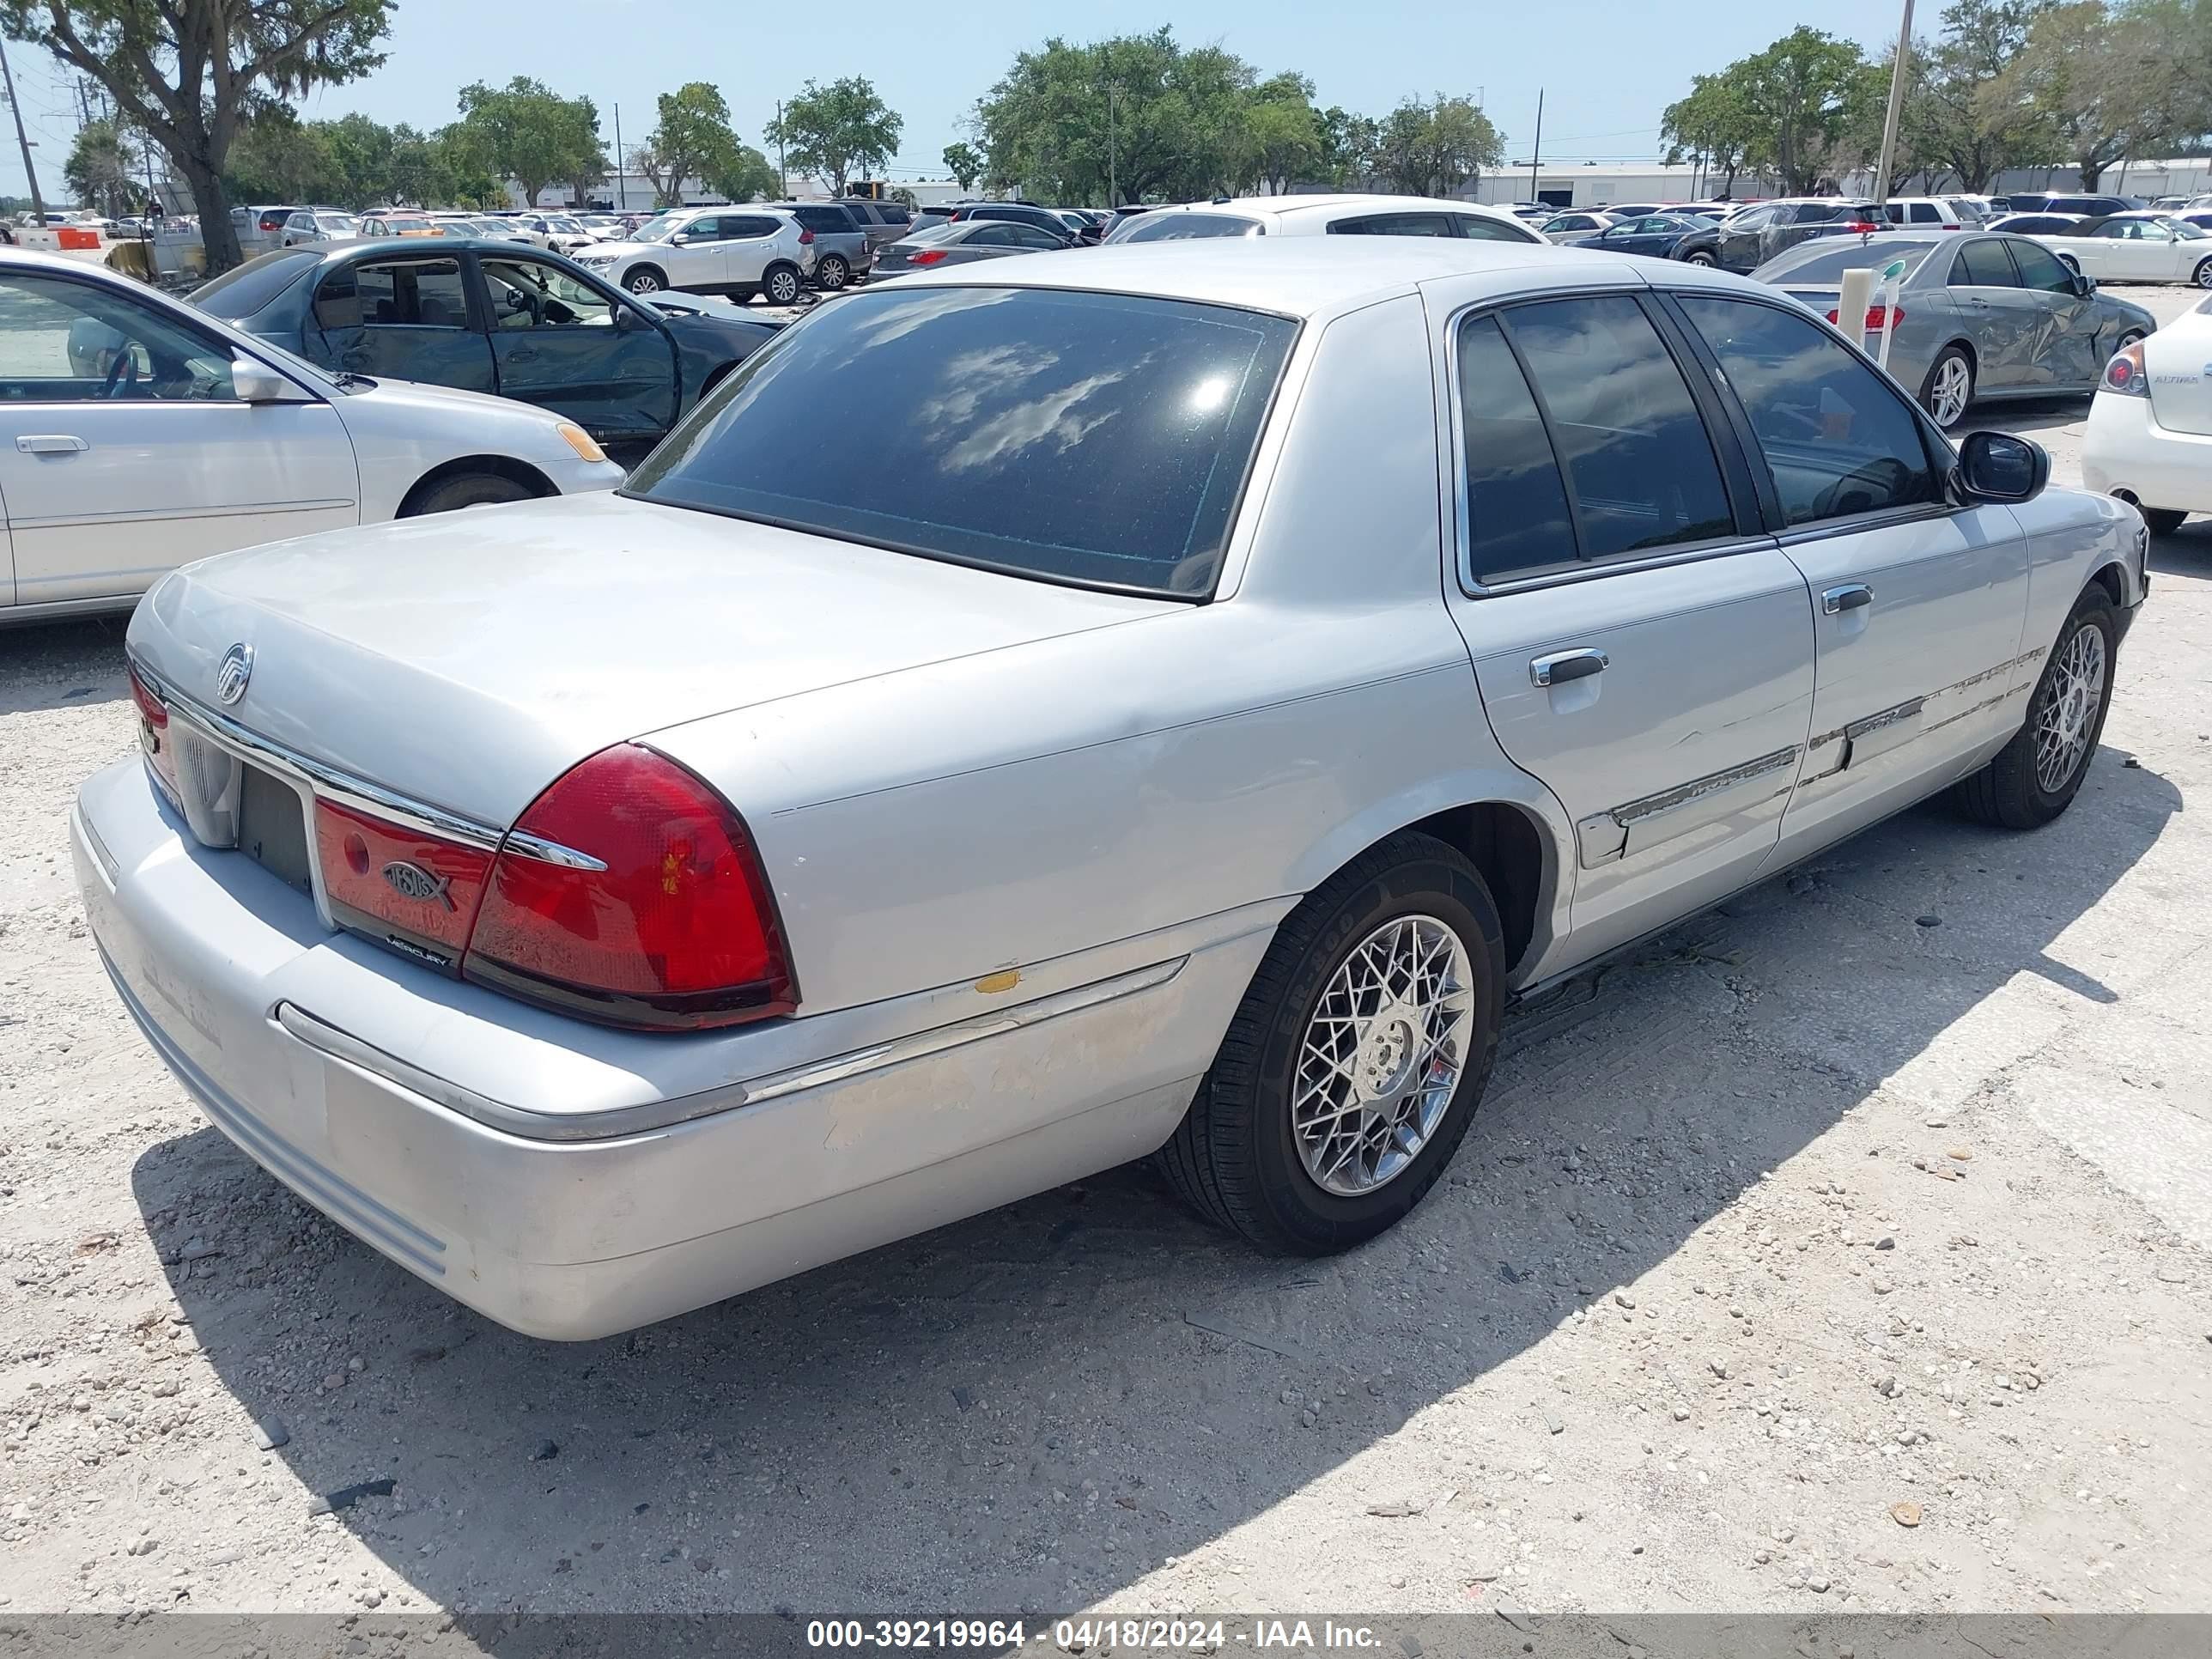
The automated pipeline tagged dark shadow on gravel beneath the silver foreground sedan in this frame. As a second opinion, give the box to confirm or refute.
[133,748,2181,1617]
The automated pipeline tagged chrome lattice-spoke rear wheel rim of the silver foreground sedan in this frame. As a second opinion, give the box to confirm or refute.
[1290,915,1475,1199]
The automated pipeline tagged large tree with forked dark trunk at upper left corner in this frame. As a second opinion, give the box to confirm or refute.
[0,0,392,272]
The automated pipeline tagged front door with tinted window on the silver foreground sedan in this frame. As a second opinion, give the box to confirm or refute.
[1672,295,2028,860]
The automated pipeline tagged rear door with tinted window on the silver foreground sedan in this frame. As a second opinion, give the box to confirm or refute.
[1451,295,1814,956]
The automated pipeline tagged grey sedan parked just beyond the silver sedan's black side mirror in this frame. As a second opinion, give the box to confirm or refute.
[1752,232,2159,431]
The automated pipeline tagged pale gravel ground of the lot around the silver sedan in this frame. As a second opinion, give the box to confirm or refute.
[0,289,2212,1617]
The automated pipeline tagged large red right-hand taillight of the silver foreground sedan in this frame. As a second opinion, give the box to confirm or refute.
[462,744,799,1026]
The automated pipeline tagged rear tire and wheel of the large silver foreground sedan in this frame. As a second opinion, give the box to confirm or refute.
[1159,832,1504,1256]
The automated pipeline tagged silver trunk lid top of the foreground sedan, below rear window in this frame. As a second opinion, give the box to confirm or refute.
[131,495,1183,825]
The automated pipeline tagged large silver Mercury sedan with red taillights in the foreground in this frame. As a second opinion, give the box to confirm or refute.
[70,237,2146,1338]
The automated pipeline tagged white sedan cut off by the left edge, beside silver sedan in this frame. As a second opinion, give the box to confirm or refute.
[0,248,622,622]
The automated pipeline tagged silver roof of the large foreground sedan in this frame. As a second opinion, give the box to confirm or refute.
[880,235,1771,319]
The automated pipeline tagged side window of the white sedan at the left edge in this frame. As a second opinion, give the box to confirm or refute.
[0,274,237,403]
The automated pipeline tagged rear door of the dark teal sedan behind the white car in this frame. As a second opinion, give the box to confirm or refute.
[307,254,498,392]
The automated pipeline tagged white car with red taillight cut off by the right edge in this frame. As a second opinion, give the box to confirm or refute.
[2081,299,2212,535]
